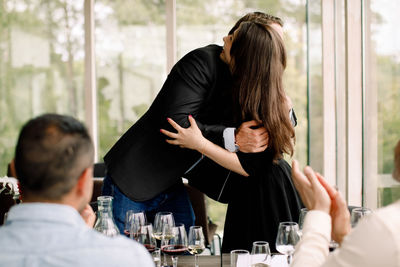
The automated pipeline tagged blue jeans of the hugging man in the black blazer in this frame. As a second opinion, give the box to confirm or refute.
[102,175,195,234]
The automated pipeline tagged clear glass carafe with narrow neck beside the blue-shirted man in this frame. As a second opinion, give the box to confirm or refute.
[93,196,119,236]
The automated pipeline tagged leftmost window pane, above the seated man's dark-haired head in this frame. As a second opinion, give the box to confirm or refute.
[0,0,85,176]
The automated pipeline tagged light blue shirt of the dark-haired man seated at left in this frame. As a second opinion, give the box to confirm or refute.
[0,203,154,267]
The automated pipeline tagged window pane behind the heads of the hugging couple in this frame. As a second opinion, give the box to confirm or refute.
[176,0,310,236]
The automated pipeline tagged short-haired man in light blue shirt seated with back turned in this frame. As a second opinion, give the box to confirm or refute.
[0,114,154,267]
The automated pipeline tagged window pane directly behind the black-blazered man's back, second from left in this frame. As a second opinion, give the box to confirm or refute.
[95,0,166,159]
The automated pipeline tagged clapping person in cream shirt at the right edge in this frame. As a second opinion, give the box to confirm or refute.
[291,142,400,267]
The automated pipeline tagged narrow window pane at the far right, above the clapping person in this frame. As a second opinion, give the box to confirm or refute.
[364,0,400,207]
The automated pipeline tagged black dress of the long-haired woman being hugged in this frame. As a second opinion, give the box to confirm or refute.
[222,149,303,253]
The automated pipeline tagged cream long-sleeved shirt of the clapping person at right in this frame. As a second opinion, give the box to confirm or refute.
[291,201,400,267]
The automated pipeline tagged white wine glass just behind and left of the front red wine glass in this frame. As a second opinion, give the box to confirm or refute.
[153,211,175,265]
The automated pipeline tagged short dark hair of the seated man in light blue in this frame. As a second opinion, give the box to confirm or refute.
[15,114,94,200]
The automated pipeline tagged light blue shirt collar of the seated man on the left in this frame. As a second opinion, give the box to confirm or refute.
[6,203,85,226]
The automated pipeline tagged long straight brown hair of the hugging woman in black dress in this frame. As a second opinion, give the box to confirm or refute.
[230,19,295,159]
